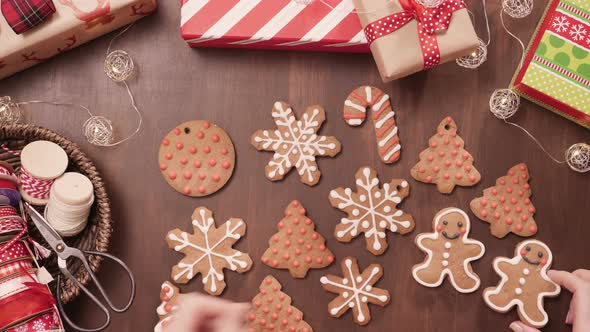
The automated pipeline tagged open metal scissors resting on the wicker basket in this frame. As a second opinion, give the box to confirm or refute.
[25,203,135,332]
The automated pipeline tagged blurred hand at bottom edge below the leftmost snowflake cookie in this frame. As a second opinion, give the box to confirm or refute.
[164,293,250,332]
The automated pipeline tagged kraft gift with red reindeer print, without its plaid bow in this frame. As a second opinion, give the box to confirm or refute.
[0,0,156,79]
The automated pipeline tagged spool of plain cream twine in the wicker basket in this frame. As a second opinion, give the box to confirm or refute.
[45,172,94,236]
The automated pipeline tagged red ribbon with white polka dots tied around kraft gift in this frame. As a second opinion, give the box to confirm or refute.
[365,0,465,69]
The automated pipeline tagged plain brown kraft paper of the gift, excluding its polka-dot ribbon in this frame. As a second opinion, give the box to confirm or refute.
[353,0,479,82]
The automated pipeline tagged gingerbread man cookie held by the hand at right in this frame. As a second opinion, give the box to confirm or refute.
[483,240,561,328]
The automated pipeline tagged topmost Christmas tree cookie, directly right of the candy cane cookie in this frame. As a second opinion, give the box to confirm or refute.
[410,117,481,194]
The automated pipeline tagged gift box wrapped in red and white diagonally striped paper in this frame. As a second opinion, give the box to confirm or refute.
[180,0,369,53]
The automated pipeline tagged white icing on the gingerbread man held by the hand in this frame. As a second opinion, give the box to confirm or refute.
[483,240,561,328]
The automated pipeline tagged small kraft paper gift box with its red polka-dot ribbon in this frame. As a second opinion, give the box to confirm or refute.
[353,0,479,82]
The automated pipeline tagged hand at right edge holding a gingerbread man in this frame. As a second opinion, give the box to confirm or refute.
[510,269,590,332]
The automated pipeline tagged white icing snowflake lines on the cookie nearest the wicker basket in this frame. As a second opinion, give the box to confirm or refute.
[168,208,248,293]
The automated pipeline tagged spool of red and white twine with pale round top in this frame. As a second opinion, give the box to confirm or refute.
[19,141,68,205]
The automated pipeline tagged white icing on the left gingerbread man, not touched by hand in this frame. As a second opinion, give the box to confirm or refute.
[412,208,485,293]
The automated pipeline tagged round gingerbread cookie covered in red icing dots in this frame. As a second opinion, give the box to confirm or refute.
[159,120,236,197]
